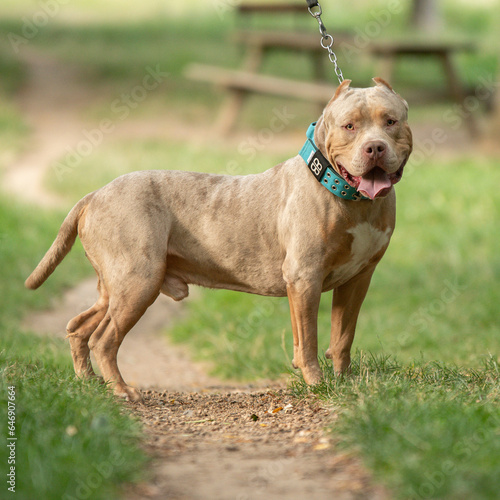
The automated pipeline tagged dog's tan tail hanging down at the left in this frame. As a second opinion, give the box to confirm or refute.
[24,193,94,290]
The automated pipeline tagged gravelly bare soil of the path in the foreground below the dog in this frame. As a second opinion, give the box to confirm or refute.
[126,389,387,500]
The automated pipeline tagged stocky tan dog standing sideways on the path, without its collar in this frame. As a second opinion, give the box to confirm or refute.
[26,79,412,400]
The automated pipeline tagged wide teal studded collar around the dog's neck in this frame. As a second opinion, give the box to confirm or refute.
[299,122,369,201]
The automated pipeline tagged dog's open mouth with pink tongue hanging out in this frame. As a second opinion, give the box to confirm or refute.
[335,159,406,200]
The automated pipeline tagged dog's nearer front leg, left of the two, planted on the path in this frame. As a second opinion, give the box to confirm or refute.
[286,280,323,384]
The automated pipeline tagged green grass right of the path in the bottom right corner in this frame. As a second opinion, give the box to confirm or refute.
[292,352,500,500]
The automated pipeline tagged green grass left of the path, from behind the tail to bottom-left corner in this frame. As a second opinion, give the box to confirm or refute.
[0,195,145,500]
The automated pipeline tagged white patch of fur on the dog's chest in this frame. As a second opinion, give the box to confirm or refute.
[334,222,391,285]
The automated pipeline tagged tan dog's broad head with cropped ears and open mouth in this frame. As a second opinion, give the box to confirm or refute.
[317,78,412,200]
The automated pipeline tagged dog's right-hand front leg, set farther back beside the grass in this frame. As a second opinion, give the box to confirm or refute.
[325,266,375,375]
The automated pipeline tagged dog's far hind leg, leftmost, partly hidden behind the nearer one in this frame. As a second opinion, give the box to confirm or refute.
[66,278,109,378]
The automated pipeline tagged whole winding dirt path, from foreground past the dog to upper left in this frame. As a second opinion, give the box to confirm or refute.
[8,48,387,500]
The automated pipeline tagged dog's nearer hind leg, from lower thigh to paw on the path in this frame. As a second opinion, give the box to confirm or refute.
[89,268,165,401]
